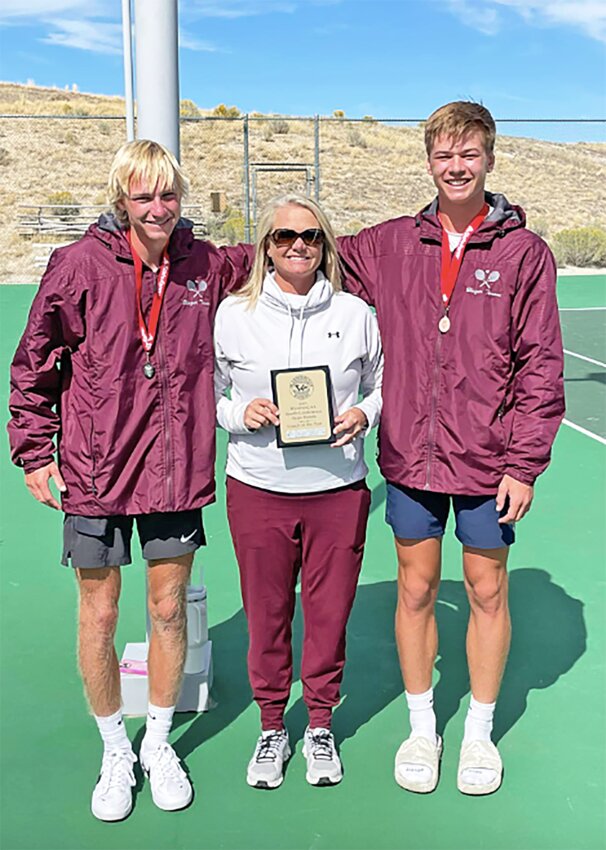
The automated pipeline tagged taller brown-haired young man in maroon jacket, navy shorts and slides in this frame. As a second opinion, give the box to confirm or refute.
[339,102,564,795]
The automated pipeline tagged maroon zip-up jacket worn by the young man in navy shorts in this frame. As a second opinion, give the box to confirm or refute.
[339,193,564,495]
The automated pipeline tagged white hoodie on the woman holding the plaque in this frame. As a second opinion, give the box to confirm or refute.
[215,272,383,493]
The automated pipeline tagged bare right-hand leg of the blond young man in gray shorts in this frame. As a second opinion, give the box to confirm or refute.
[147,554,193,707]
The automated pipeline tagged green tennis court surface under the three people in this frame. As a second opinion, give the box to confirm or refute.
[0,276,606,850]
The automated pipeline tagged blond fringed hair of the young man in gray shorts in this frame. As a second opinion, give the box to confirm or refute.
[107,139,189,224]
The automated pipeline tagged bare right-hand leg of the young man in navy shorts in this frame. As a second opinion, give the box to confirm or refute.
[463,546,511,703]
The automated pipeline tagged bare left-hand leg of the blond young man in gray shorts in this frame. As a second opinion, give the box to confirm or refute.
[76,567,121,717]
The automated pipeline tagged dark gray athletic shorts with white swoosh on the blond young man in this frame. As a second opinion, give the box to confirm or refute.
[61,508,206,569]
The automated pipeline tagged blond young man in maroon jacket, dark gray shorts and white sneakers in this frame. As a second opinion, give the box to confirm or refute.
[9,140,248,821]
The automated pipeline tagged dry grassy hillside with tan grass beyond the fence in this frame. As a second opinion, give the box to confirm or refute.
[0,83,606,281]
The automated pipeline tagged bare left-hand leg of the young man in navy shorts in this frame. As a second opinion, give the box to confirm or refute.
[395,537,442,694]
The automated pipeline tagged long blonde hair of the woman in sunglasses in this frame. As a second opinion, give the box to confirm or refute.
[236,194,342,309]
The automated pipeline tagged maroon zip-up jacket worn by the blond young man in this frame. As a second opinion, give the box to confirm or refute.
[8,216,253,516]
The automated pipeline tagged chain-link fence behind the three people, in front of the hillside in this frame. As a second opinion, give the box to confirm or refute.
[0,115,606,283]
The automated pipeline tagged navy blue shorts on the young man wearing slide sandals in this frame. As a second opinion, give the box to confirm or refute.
[385,482,515,549]
